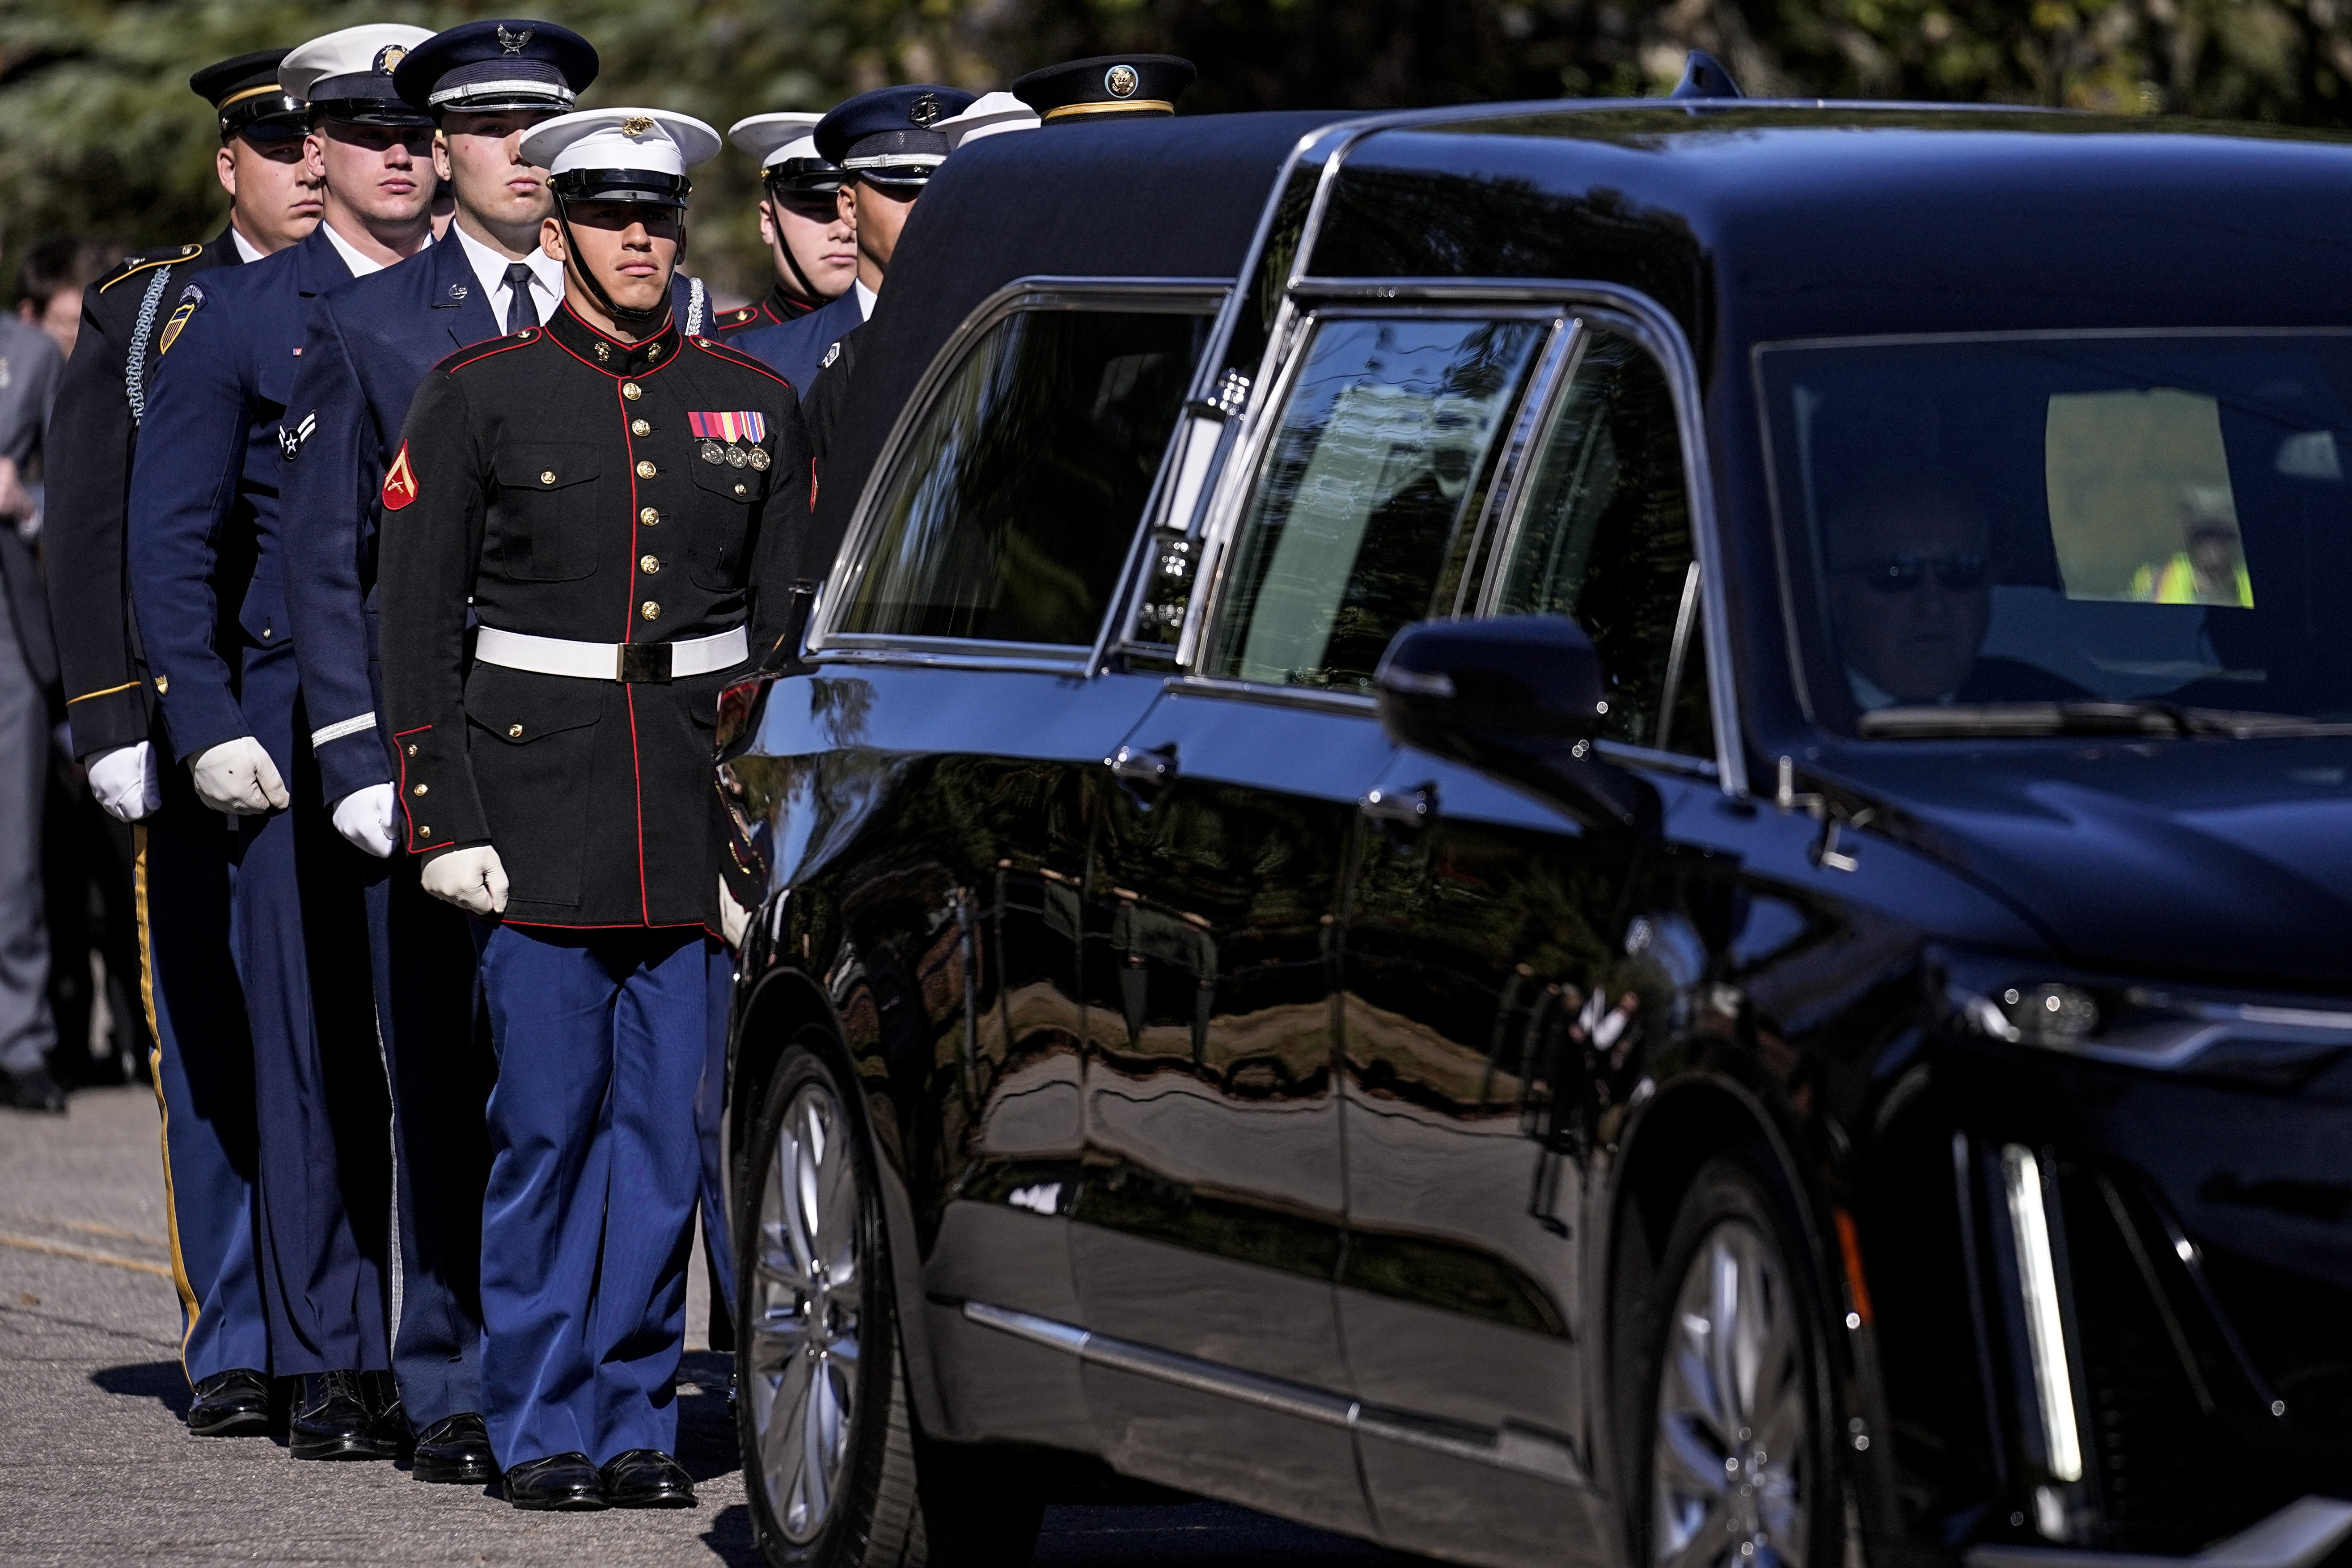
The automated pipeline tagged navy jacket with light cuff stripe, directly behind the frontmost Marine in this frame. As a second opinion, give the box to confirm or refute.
[280,253,710,804]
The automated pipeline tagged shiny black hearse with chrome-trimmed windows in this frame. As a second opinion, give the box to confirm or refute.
[722,73,2352,1568]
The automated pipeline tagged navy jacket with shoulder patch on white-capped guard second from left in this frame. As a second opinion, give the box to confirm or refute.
[129,223,351,759]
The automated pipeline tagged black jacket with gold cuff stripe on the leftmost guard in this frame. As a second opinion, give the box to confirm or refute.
[40,228,240,759]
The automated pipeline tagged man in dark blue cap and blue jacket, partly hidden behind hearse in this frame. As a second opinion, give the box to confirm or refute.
[734,87,971,397]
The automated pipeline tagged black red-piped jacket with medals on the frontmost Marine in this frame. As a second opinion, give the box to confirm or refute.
[376,306,814,931]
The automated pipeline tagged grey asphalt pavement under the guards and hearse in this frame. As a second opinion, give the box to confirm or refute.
[0,1086,1413,1568]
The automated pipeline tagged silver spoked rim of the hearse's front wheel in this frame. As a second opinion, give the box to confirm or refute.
[1649,1220,1813,1568]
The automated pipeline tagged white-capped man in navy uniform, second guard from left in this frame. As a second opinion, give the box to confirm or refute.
[129,26,435,1460]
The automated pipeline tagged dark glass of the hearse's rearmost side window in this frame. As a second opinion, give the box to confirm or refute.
[835,301,1209,647]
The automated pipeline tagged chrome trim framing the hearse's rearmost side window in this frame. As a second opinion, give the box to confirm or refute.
[804,277,1235,672]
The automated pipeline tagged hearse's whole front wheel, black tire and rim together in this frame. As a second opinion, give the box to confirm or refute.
[1620,1150,1844,1568]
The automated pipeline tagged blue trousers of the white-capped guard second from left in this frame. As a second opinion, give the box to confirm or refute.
[230,644,393,1378]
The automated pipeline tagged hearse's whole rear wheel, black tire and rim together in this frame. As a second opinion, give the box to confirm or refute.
[736,1030,1044,1568]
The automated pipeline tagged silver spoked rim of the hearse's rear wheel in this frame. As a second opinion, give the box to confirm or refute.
[743,1082,866,1547]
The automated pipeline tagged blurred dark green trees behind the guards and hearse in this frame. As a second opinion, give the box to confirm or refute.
[0,0,2352,294]
